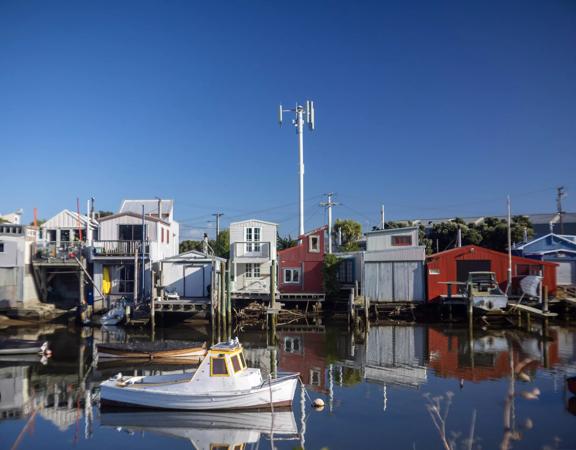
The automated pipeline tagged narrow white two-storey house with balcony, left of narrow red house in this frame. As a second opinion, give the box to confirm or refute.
[230,219,278,299]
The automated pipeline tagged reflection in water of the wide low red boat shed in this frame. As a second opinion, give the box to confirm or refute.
[428,327,558,381]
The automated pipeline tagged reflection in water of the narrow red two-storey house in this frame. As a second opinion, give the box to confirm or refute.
[278,331,327,393]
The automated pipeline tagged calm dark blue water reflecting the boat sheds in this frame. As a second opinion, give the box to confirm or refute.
[0,325,576,450]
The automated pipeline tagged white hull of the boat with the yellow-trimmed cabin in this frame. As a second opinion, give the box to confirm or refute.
[100,375,298,411]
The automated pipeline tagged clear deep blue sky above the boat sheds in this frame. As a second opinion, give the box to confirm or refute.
[0,0,576,237]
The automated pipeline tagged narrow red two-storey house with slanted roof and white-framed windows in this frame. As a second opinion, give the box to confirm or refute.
[278,226,328,294]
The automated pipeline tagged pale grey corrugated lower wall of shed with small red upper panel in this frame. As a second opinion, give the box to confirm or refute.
[364,261,425,302]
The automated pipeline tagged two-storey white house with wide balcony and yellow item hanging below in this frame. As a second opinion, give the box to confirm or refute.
[89,200,179,300]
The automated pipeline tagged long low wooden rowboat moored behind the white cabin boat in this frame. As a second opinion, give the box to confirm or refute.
[96,341,206,360]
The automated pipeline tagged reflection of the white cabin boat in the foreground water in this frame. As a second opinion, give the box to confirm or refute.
[100,411,299,450]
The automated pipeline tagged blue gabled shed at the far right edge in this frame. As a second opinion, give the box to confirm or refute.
[513,233,576,286]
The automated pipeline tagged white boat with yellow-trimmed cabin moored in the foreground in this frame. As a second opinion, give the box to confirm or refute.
[100,339,299,411]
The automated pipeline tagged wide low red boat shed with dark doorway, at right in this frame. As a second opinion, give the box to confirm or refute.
[426,245,556,301]
